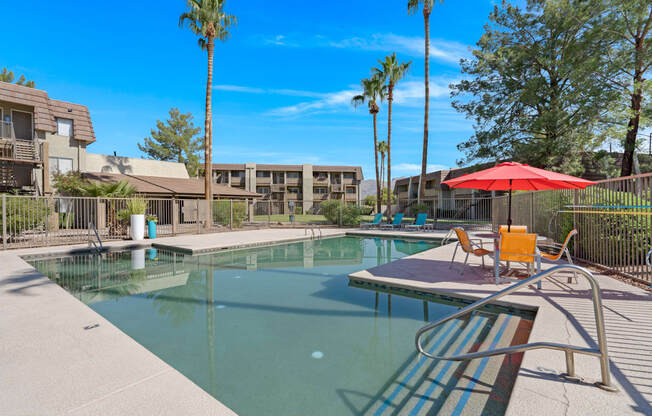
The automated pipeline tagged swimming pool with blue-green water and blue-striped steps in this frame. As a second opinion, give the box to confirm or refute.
[28,237,529,415]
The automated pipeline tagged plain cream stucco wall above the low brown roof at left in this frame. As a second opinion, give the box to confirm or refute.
[84,151,189,179]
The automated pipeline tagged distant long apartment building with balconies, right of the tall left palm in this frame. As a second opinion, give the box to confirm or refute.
[213,163,363,212]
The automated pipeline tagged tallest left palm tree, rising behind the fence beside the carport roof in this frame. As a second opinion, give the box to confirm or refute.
[179,0,237,221]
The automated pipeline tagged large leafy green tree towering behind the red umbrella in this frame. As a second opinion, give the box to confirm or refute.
[451,1,616,174]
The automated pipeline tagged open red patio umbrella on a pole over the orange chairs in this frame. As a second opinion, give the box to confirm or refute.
[442,162,595,229]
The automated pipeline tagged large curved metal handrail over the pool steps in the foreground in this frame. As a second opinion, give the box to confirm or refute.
[414,265,616,391]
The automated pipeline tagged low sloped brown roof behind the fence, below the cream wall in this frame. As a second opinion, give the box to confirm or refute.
[83,172,261,198]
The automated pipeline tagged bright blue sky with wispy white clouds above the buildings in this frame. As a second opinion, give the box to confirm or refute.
[0,0,500,178]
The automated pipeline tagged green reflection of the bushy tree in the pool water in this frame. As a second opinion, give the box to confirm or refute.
[147,271,206,328]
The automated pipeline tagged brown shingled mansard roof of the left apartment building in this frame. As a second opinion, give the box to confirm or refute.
[0,82,95,143]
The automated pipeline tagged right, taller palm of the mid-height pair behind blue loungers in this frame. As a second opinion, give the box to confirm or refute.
[374,52,412,221]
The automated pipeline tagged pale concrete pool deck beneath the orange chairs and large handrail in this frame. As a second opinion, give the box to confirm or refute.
[350,236,652,416]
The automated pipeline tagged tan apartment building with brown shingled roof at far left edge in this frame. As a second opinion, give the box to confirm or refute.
[0,82,95,195]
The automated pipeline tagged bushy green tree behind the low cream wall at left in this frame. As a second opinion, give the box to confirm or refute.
[138,108,203,176]
